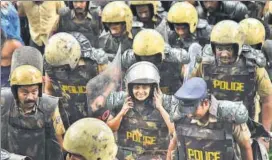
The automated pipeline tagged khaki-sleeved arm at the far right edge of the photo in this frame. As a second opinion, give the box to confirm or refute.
[256,68,272,146]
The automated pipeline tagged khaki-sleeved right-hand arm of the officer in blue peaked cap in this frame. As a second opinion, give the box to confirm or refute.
[233,123,253,160]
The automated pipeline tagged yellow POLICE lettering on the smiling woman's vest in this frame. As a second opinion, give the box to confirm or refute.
[127,130,156,146]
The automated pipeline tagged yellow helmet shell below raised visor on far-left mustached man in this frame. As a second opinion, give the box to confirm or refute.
[10,65,43,86]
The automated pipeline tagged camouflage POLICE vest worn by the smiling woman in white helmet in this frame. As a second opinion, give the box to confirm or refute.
[118,106,169,159]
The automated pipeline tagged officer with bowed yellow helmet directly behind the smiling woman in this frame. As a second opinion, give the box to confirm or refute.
[122,29,190,95]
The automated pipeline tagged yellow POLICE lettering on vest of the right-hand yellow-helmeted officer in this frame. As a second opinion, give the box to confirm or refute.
[213,79,244,92]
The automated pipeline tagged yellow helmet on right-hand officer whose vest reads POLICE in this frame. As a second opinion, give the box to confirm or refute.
[211,20,245,58]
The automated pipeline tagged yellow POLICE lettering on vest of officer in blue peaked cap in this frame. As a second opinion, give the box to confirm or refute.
[187,148,220,160]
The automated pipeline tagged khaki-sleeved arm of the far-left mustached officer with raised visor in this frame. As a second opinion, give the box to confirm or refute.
[52,106,65,148]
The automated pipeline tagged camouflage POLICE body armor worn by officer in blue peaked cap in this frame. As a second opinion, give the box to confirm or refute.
[171,96,248,160]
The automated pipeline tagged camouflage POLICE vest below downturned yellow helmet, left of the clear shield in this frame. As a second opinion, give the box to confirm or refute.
[45,59,98,126]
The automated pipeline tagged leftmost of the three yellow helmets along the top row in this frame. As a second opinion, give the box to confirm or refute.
[102,1,133,38]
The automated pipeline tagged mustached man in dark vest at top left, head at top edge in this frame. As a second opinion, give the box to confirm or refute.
[58,1,101,47]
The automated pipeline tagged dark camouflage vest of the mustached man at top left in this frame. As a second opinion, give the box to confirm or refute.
[58,10,100,47]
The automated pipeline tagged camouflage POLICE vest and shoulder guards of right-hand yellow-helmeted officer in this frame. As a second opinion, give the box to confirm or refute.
[203,46,257,118]
